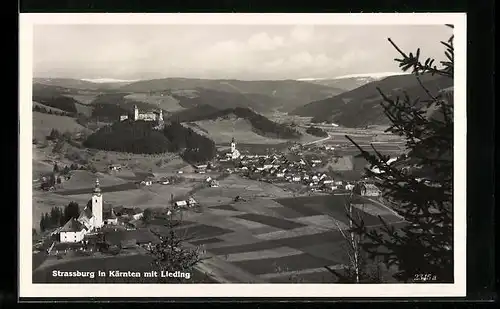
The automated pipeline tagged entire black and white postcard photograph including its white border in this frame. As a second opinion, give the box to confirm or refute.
[19,13,466,297]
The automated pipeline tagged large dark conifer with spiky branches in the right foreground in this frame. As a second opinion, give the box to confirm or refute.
[346,25,454,283]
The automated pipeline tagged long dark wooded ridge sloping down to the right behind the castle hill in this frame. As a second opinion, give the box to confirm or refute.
[172,107,301,139]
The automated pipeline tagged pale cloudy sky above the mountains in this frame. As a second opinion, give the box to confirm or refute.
[33,24,451,80]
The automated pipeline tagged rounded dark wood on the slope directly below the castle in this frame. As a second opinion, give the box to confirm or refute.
[83,120,170,154]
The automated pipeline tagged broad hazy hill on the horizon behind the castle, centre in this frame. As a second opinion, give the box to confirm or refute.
[120,78,343,110]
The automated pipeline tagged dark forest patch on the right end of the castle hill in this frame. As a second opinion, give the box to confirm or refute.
[163,122,216,163]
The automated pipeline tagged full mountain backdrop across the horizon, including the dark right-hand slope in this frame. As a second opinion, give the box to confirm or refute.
[33,72,453,127]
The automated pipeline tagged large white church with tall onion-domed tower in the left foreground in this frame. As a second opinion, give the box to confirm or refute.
[59,179,105,243]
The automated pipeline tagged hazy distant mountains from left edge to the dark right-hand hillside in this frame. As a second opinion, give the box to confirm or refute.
[33,78,344,112]
